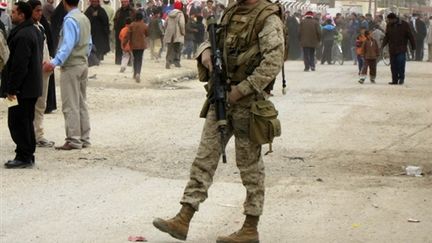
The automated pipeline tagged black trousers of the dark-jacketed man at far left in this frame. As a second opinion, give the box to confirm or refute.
[8,98,37,161]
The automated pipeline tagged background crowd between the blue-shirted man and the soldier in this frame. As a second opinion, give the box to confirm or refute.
[109,0,219,78]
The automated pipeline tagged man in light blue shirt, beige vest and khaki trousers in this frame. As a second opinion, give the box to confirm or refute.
[43,0,91,150]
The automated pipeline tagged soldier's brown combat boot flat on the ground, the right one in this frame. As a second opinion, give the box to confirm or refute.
[216,215,259,243]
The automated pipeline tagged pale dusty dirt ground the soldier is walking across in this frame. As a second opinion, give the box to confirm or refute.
[0,53,432,243]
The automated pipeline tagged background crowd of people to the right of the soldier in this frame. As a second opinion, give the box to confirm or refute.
[285,11,432,84]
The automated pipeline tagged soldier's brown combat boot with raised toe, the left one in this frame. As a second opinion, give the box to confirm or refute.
[153,204,195,240]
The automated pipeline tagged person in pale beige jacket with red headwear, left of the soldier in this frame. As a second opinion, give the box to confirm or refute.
[164,2,186,69]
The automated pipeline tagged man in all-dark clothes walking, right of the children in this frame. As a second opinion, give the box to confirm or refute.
[381,13,416,85]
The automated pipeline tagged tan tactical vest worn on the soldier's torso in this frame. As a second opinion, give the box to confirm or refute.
[218,0,282,84]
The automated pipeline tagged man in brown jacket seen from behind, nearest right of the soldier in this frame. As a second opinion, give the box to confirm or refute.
[300,11,321,72]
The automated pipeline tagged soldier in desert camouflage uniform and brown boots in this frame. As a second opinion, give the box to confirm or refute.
[153,0,284,243]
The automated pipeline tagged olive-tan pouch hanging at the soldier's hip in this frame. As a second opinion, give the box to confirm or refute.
[249,100,281,144]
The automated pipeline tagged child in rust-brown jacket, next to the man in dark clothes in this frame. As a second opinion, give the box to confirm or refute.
[359,31,380,84]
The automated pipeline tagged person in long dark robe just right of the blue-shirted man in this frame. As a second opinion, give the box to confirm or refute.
[84,0,110,61]
